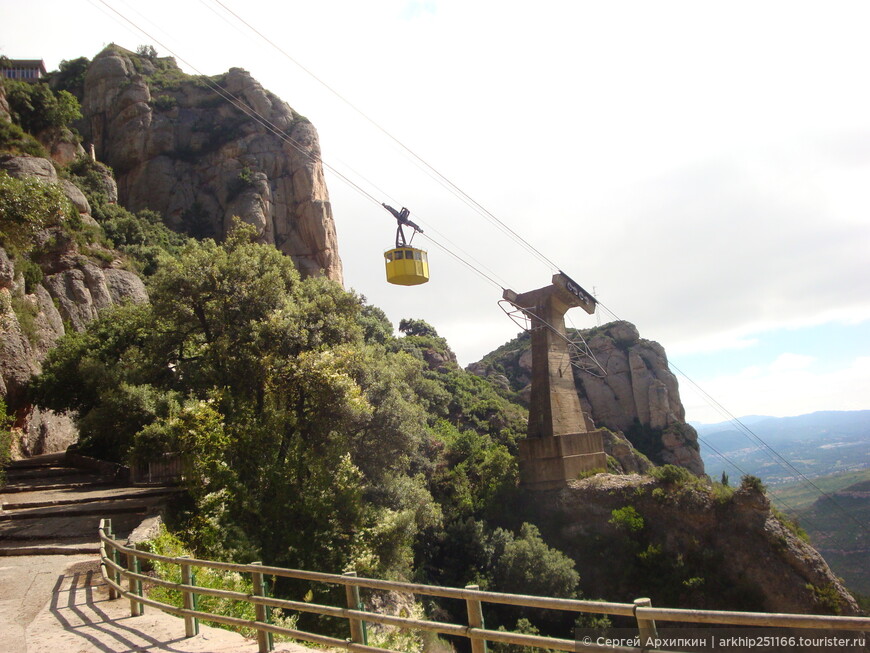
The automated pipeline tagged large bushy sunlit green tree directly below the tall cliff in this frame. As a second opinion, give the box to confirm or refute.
[33,225,440,574]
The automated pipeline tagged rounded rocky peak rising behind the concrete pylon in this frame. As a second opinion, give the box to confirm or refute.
[468,322,704,475]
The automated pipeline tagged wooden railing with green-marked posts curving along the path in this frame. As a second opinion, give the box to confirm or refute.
[99,519,870,653]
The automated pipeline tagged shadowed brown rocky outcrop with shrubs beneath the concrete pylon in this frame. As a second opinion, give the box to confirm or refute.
[525,474,860,615]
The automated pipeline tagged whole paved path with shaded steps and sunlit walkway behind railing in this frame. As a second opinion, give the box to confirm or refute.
[0,454,311,653]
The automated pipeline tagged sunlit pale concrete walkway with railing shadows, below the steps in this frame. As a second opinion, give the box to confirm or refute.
[0,555,311,653]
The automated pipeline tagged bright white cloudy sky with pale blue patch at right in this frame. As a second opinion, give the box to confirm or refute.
[0,0,870,423]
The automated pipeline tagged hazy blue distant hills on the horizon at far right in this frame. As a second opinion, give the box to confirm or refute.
[693,410,870,486]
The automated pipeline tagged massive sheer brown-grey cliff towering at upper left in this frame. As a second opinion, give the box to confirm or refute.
[82,46,342,283]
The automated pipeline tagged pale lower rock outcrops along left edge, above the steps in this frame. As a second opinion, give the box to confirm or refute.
[0,155,148,456]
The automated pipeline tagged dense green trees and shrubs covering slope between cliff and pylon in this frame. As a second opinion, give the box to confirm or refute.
[32,215,596,636]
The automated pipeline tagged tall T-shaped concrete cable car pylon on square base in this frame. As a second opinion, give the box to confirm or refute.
[504,272,607,490]
